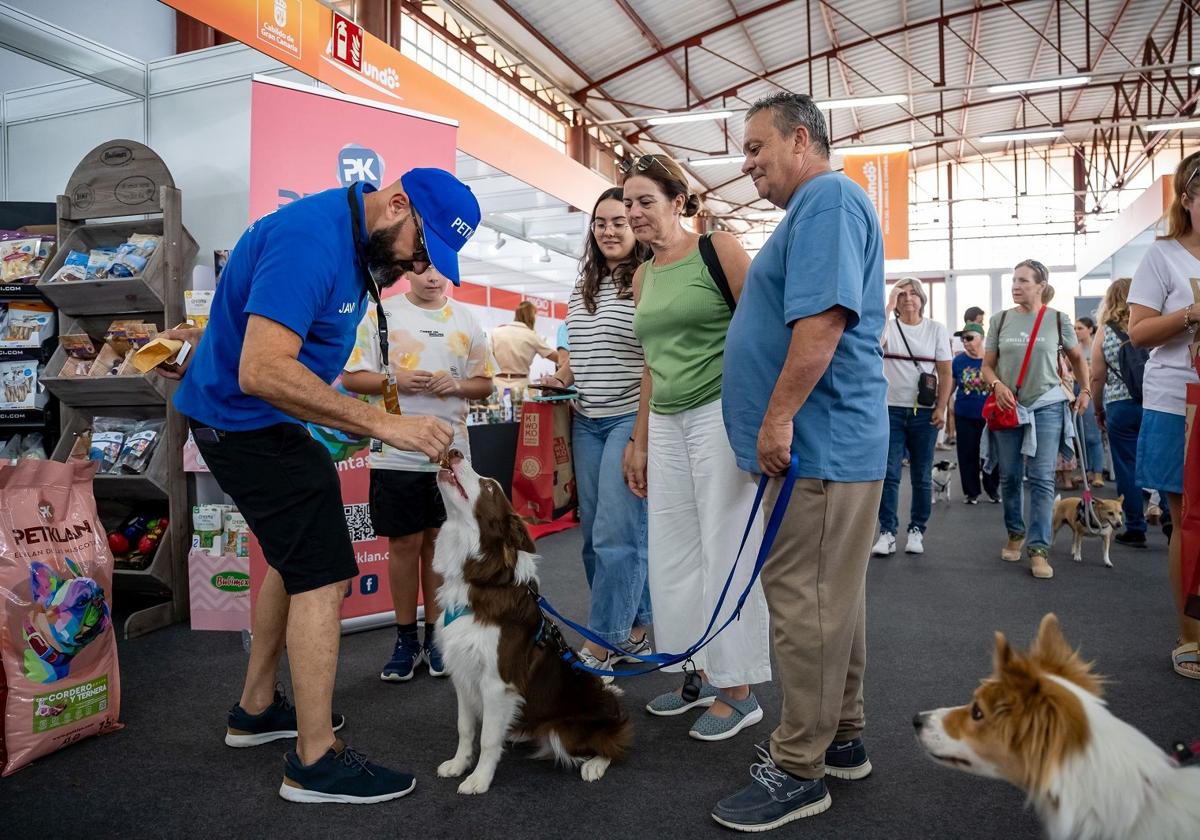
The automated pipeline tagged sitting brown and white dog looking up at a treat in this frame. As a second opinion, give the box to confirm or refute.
[433,451,632,793]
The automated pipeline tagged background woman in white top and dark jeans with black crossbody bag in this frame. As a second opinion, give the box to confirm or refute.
[871,277,954,554]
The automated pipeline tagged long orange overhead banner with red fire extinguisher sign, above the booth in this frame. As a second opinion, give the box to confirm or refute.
[163,0,612,208]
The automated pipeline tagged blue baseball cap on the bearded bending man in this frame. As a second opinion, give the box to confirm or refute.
[400,167,480,286]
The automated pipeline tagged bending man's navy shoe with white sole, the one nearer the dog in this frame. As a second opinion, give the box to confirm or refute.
[280,740,416,805]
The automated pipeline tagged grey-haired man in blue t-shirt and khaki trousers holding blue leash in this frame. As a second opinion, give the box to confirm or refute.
[713,94,888,832]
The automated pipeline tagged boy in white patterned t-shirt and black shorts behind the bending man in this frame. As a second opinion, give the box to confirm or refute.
[342,269,496,683]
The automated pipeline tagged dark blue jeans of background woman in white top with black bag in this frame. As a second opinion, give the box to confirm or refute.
[880,406,937,534]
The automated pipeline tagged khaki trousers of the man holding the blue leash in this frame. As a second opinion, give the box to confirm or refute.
[762,479,883,779]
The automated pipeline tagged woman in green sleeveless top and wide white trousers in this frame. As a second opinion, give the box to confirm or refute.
[624,155,770,740]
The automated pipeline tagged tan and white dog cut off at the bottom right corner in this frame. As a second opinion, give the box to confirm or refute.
[913,613,1200,840]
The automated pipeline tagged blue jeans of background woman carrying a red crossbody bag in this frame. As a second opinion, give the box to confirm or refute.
[992,402,1067,550]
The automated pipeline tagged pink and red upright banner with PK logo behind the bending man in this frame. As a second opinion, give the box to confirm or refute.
[250,78,456,619]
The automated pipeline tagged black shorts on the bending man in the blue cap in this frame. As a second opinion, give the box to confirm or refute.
[192,421,359,595]
